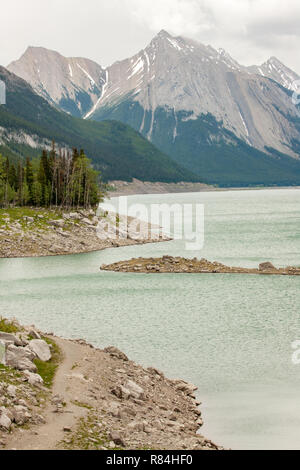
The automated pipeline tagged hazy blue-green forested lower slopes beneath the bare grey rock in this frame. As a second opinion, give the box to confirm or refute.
[93,96,300,187]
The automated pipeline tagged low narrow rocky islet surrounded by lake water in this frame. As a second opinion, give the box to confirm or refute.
[101,256,300,276]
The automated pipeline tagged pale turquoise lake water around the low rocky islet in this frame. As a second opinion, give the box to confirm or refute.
[0,189,300,449]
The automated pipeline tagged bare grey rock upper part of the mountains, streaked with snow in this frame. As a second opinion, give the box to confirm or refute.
[8,30,300,164]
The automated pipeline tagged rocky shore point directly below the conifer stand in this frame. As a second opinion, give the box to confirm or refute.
[0,209,168,258]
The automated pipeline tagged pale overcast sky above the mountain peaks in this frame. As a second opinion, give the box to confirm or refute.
[0,0,300,74]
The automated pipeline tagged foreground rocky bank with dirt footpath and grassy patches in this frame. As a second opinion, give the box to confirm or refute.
[0,320,221,450]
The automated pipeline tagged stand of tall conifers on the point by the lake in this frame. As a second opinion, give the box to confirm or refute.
[0,143,103,209]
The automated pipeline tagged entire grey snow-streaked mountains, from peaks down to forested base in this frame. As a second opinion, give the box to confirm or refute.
[4,30,300,186]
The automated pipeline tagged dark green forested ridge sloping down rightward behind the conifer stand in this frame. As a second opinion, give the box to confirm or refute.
[0,67,197,182]
